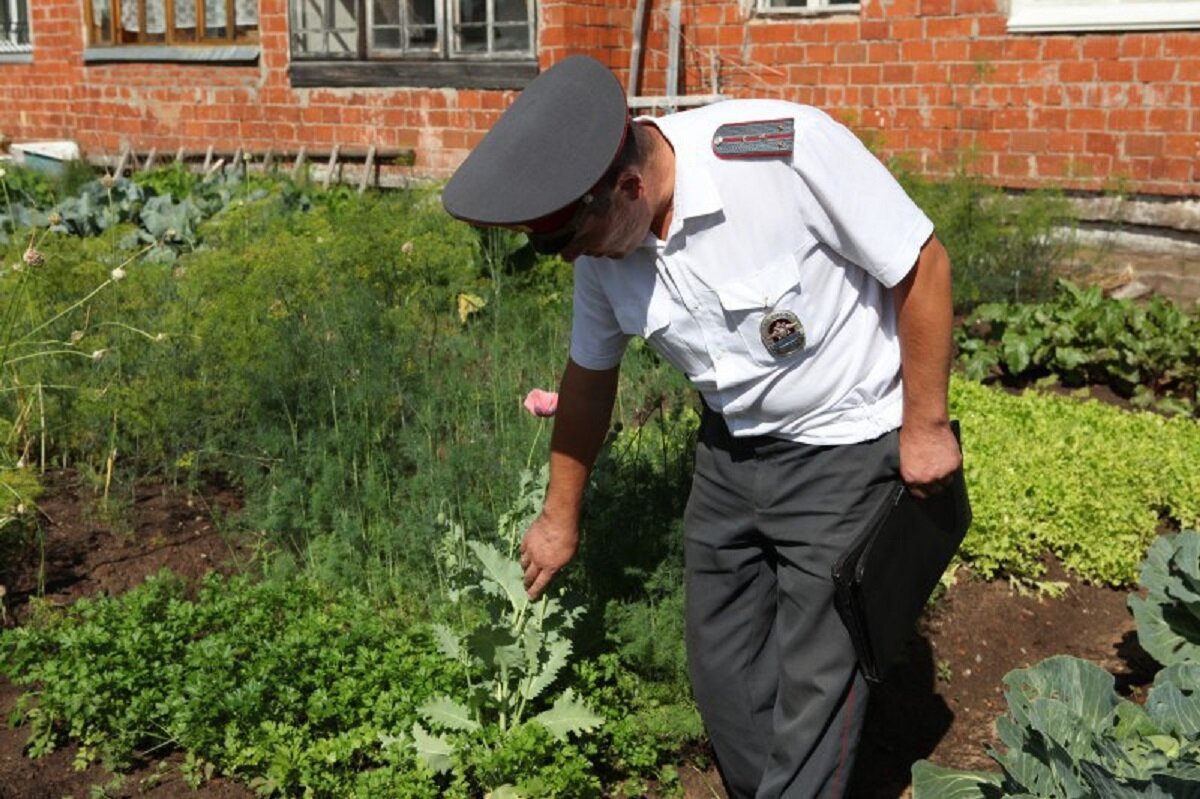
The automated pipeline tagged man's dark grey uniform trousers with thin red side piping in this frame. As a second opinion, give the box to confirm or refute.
[684,411,900,799]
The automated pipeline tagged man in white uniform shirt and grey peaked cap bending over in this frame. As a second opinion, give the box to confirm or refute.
[443,56,961,799]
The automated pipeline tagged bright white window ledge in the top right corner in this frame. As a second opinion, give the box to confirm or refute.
[1008,0,1200,32]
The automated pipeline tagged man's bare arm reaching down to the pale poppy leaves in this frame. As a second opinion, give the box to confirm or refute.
[521,360,618,599]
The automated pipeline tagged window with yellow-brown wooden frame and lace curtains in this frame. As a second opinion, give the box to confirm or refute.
[85,0,258,47]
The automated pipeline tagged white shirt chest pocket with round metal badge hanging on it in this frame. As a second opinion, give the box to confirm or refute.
[713,247,824,366]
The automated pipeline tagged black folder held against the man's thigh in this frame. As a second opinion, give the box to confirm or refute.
[833,423,971,683]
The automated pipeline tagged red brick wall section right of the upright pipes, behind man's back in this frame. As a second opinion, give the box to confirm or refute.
[622,0,1200,196]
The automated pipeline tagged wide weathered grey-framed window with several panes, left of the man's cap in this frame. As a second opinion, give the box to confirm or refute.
[288,0,536,60]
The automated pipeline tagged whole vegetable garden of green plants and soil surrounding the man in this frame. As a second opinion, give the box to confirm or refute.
[0,164,1200,799]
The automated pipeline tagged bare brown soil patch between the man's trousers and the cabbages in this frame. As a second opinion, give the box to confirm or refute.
[850,564,1158,799]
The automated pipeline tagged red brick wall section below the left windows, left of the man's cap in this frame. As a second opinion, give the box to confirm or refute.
[0,0,514,175]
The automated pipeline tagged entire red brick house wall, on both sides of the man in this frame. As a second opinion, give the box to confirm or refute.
[0,0,1200,196]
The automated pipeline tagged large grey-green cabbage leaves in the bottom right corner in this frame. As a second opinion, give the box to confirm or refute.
[912,531,1200,799]
